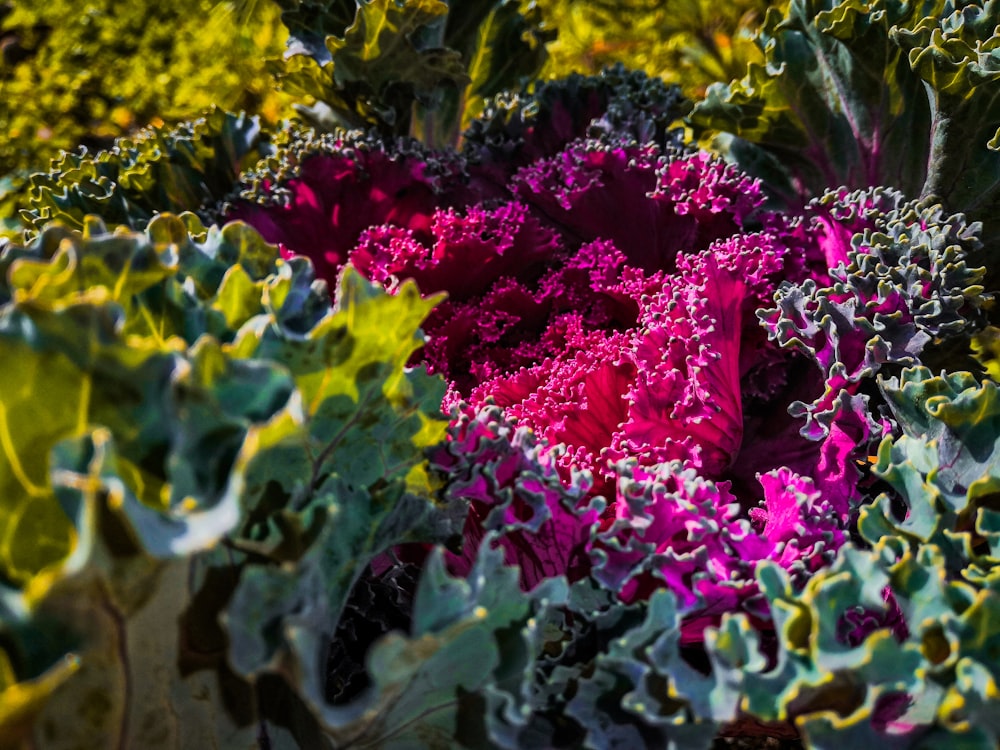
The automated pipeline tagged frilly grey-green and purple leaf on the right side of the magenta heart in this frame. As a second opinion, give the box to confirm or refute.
[757,188,992,496]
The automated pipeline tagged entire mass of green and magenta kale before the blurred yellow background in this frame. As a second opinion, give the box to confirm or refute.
[0,0,1000,750]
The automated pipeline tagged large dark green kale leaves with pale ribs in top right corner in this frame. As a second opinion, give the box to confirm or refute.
[690,0,1000,440]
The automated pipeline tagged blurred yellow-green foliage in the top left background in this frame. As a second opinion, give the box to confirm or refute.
[0,0,290,175]
